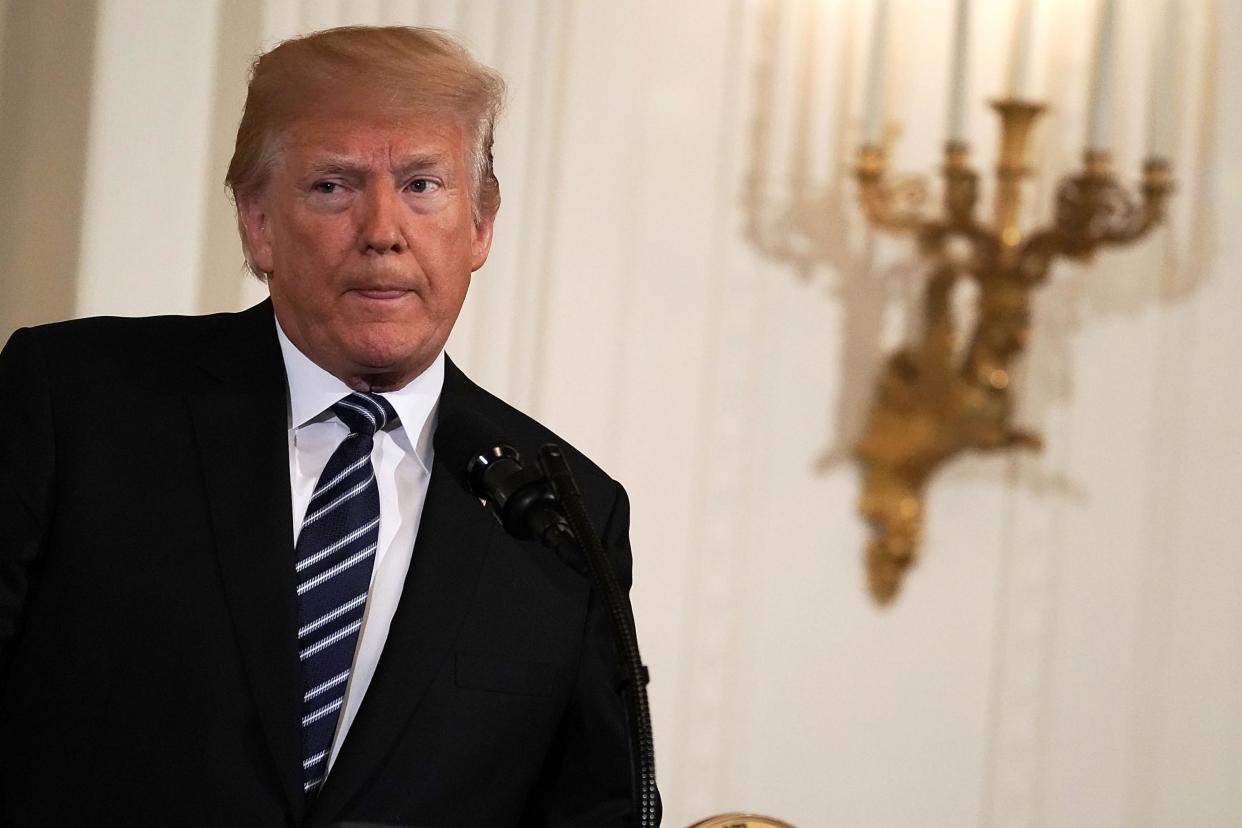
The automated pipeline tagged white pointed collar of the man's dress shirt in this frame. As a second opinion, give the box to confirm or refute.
[276,320,445,474]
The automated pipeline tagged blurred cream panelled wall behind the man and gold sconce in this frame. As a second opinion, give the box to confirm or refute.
[0,0,1242,828]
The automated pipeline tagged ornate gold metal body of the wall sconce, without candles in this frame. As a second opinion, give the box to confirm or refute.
[854,99,1172,603]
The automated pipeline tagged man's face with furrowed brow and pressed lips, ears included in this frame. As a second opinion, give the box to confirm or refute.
[240,115,492,390]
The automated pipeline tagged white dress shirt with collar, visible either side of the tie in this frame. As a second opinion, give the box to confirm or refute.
[276,323,445,770]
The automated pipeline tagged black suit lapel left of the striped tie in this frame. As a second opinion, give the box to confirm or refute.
[189,303,304,821]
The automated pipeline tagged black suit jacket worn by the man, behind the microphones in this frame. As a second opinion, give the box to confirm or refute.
[0,303,631,826]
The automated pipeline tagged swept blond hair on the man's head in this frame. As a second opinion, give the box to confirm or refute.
[225,26,504,261]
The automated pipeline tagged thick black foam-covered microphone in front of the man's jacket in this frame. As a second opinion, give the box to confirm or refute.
[433,411,573,549]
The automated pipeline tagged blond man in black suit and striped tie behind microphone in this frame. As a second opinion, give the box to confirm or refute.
[0,22,650,826]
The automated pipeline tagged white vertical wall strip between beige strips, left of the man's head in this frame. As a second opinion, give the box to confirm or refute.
[77,0,219,315]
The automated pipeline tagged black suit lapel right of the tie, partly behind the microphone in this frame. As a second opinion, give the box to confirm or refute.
[309,362,502,824]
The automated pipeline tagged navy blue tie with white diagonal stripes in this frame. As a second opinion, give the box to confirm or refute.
[294,394,396,796]
